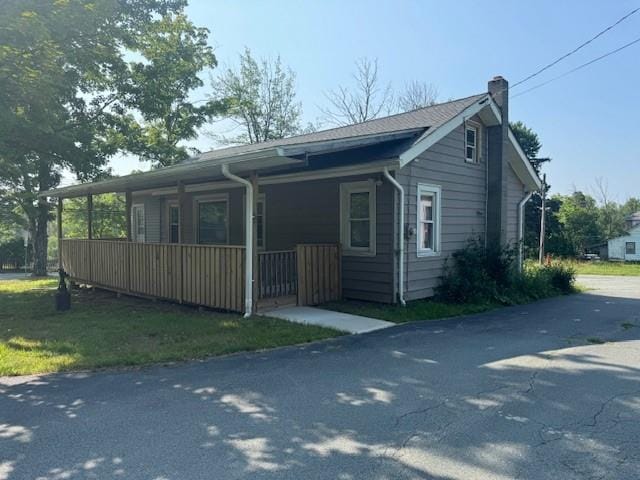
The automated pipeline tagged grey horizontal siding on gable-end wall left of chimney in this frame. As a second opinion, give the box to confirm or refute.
[398,120,487,300]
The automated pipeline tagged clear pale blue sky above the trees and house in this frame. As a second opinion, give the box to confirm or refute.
[106,0,640,201]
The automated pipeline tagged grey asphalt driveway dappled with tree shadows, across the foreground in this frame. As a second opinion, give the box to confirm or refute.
[0,277,640,480]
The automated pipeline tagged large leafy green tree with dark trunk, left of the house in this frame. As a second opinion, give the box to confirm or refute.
[0,0,215,275]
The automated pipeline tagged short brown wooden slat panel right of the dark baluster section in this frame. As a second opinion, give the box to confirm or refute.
[296,244,342,305]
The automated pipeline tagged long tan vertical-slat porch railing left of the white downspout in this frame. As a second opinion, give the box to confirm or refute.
[61,239,244,312]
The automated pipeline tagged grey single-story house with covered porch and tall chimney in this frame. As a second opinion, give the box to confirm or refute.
[45,77,540,313]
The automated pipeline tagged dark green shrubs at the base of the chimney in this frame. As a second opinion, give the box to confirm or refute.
[437,240,575,305]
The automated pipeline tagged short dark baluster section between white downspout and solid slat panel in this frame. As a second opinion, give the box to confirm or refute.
[258,250,298,299]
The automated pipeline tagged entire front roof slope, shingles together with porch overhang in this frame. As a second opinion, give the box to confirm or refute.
[40,93,487,198]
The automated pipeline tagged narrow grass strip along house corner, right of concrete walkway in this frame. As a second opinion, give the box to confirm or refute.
[322,300,501,323]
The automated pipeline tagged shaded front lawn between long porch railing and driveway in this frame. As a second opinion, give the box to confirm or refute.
[0,279,341,375]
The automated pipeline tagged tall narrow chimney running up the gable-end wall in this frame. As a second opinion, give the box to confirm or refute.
[487,76,515,245]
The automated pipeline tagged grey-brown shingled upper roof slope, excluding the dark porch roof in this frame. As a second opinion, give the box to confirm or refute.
[190,93,487,161]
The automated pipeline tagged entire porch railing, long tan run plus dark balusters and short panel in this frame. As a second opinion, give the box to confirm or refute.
[60,239,341,312]
